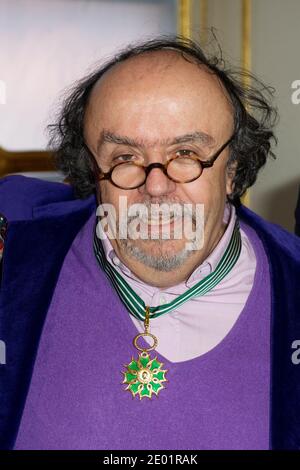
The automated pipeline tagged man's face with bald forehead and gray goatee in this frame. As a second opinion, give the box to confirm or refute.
[85,51,233,285]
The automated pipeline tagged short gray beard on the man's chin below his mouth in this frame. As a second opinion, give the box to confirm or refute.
[119,239,193,272]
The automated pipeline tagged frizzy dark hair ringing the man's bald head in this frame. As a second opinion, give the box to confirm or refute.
[48,36,277,202]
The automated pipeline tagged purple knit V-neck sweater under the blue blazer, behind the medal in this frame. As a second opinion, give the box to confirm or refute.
[15,215,270,450]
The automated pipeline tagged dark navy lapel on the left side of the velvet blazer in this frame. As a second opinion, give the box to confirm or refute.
[0,197,96,449]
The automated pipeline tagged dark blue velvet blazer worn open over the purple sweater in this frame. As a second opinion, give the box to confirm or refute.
[0,176,300,449]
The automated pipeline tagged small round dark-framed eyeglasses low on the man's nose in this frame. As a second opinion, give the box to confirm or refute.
[91,134,235,190]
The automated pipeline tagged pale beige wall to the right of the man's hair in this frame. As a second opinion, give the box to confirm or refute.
[192,0,300,231]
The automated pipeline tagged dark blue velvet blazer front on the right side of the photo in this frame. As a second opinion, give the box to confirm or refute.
[238,207,300,450]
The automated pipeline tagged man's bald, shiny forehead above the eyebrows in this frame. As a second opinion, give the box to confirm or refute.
[85,51,232,144]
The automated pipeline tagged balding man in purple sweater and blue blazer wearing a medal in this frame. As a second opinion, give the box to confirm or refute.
[0,39,300,449]
